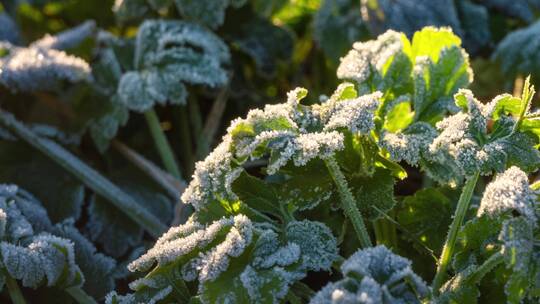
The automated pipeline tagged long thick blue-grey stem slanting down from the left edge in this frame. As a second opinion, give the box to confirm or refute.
[0,109,167,237]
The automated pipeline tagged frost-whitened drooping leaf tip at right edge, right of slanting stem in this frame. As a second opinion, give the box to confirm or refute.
[478,167,537,226]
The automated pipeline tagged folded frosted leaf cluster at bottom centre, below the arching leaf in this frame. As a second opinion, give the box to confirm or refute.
[107,215,337,303]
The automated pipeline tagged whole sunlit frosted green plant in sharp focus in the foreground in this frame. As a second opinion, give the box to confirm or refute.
[107,28,540,303]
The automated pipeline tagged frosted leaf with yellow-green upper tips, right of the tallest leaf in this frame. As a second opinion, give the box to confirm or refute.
[427,90,540,182]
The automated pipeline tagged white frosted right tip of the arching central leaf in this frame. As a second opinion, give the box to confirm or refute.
[324,92,382,134]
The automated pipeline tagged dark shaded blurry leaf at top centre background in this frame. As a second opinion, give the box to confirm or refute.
[227,16,294,77]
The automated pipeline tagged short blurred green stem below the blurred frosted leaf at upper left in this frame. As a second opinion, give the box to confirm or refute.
[144,109,182,179]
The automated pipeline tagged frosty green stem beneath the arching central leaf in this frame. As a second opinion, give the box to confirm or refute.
[325,157,372,248]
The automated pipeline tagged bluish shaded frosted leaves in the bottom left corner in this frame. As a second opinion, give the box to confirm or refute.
[0,185,84,288]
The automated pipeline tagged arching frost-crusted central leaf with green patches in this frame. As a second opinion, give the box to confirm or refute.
[182,84,381,210]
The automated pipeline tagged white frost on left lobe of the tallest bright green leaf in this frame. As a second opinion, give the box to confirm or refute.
[337,30,403,83]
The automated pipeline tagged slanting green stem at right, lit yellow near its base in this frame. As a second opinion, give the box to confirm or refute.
[432,172,479,295]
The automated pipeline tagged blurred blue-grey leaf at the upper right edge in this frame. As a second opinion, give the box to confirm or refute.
[492,21,540,79]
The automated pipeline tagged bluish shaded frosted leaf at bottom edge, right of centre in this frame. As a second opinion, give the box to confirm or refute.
[310,246,429,304]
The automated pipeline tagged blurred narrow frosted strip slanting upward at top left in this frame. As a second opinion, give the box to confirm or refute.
[30,20,96,50]
